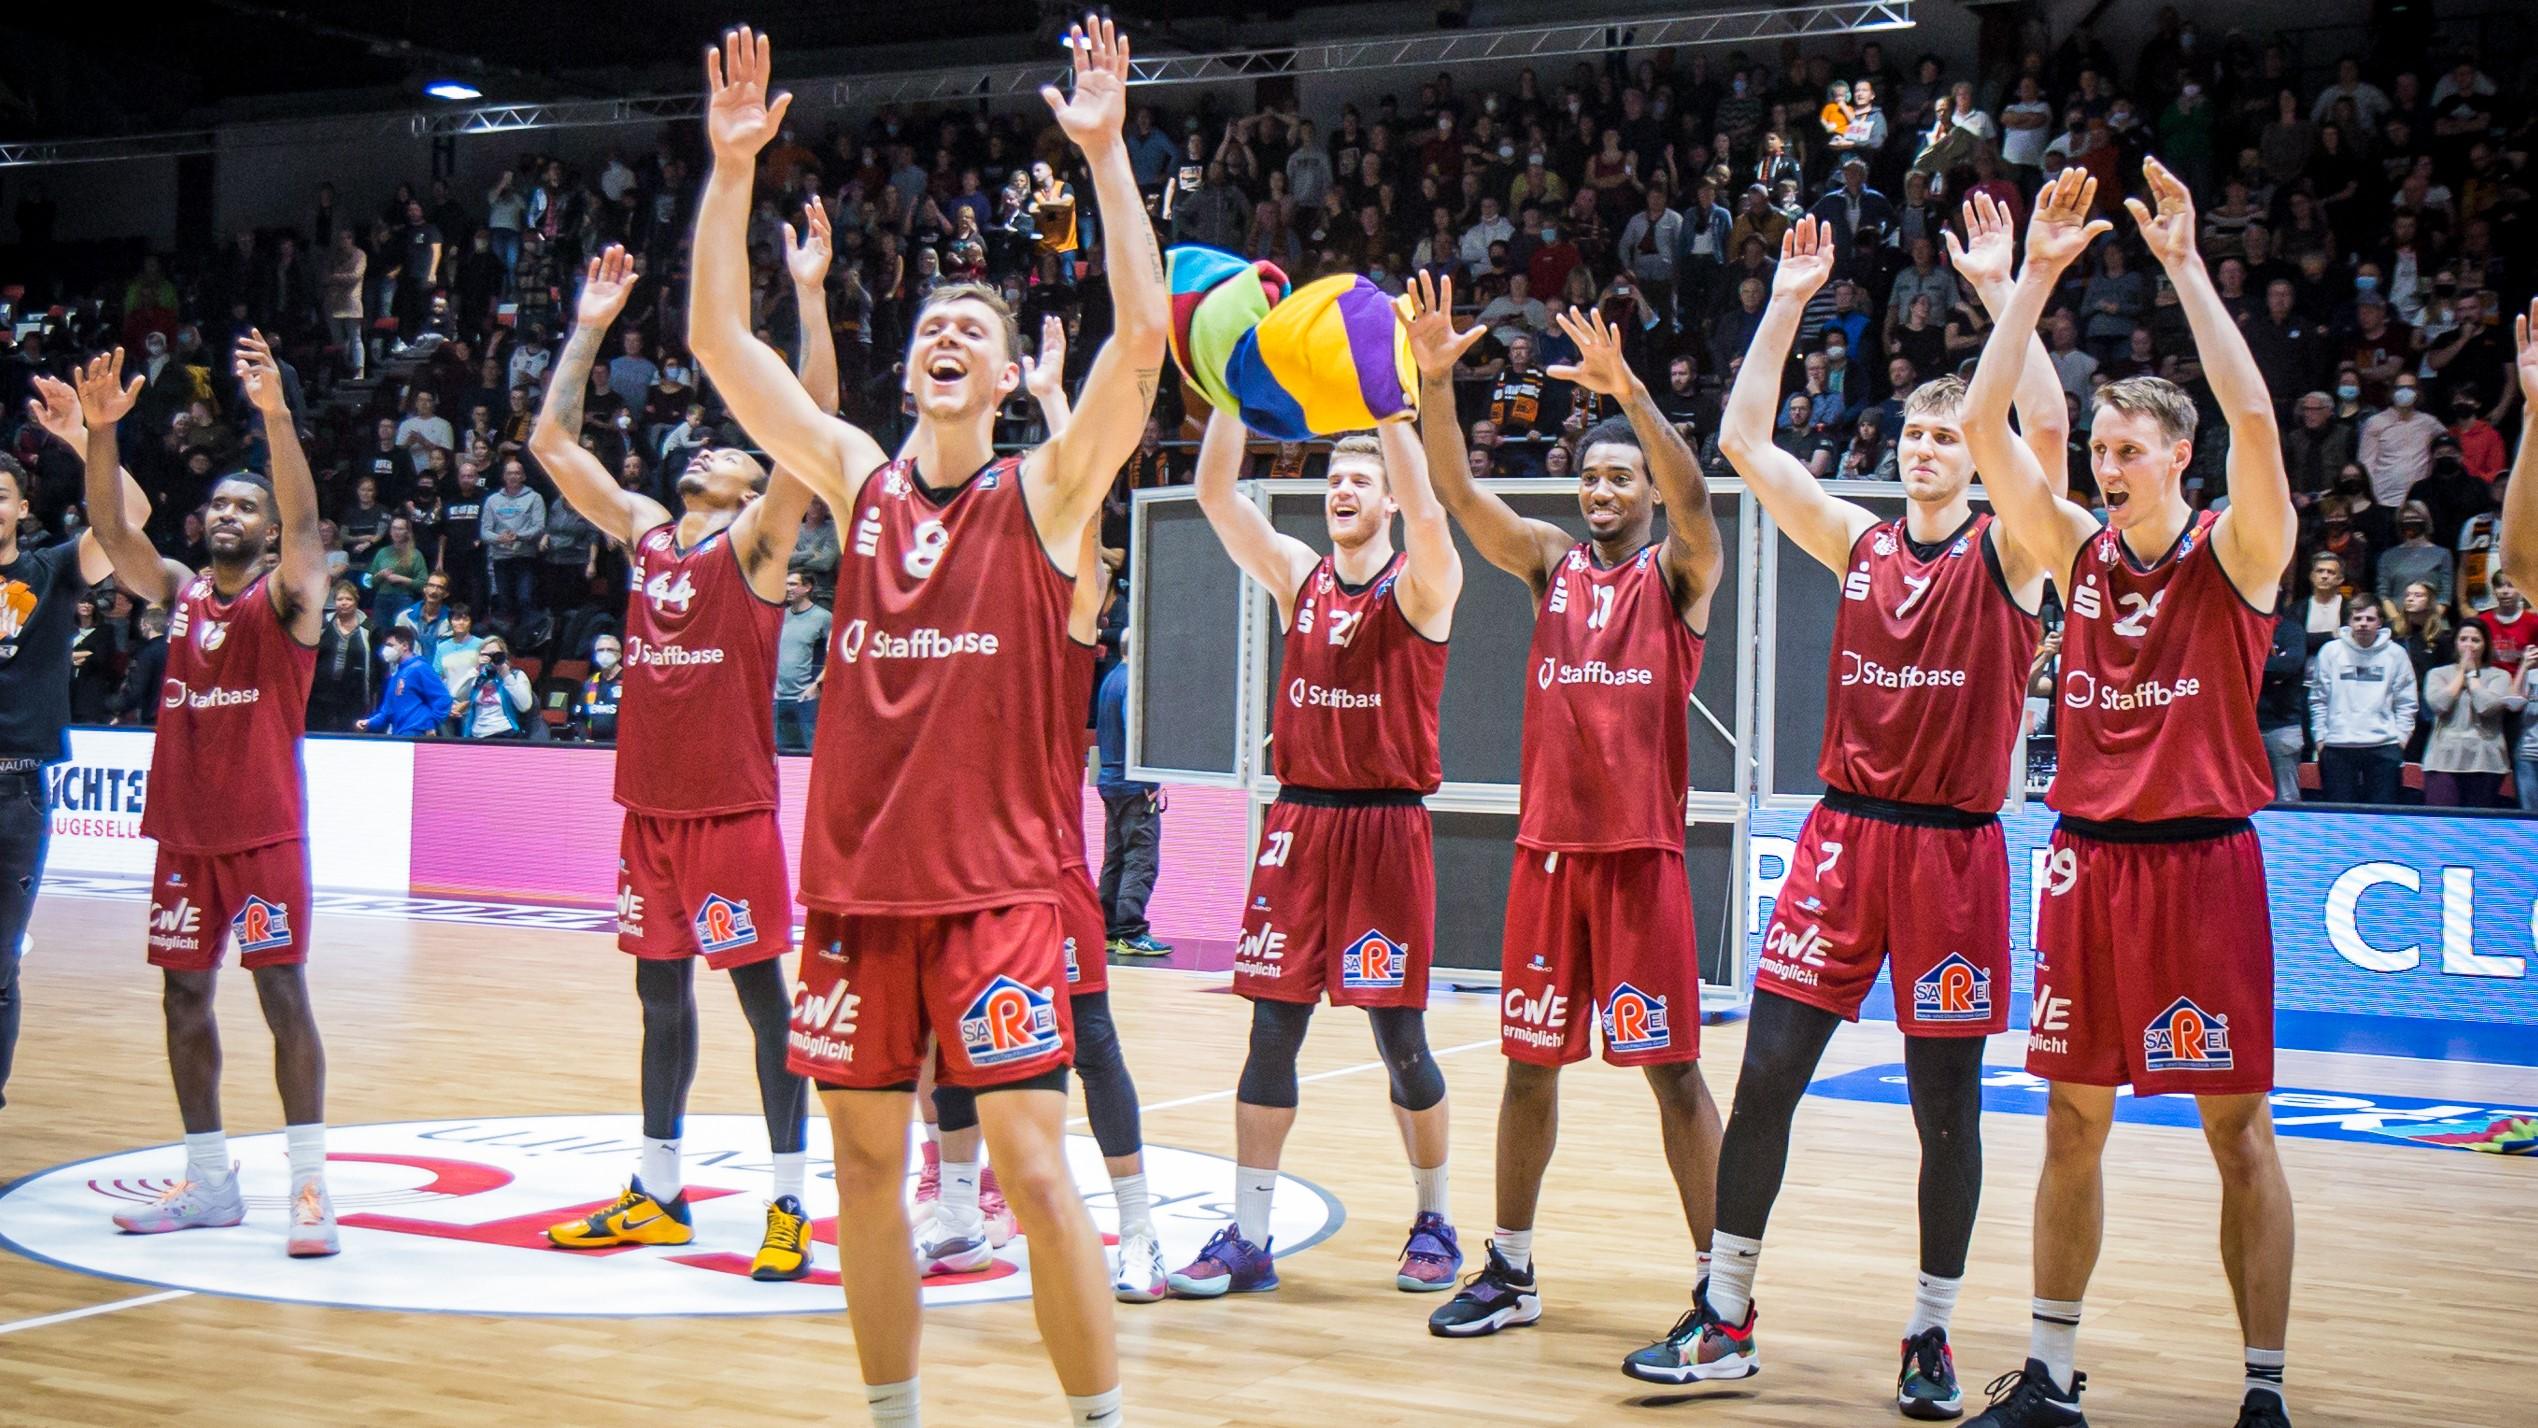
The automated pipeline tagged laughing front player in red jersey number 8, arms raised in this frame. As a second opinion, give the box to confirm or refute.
[688,18,1170,1428]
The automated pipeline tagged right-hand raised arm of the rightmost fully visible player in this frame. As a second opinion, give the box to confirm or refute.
[2124,160,2299,609]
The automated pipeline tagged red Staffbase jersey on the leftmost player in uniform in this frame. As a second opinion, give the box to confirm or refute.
[142,576,317,852]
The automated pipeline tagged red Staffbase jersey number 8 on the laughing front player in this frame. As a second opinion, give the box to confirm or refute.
[796,457,1084,916]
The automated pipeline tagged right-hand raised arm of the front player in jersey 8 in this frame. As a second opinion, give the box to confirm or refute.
[1023,18,1173,555]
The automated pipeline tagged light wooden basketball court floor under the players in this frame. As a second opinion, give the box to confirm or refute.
[0,895,2538,1428]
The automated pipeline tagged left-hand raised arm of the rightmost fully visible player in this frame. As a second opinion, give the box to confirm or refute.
[1964,167,2112,583]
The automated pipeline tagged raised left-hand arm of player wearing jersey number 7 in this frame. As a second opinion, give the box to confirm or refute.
[1718,216,1878,571]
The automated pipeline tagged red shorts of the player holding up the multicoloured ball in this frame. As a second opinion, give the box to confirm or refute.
[1233,794,1437,1007]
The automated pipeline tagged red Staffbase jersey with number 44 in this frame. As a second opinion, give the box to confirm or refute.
[617,523,784,819]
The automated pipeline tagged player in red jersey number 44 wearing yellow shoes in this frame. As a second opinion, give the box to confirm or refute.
[528,239,838,1281]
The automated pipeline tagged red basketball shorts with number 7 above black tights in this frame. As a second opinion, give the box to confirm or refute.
[1754,796,2010,1037]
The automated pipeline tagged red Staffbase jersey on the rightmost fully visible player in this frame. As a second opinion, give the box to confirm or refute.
[2046,512,2274,822]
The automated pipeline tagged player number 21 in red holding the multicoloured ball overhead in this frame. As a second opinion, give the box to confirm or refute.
[1173,411,1462,1299]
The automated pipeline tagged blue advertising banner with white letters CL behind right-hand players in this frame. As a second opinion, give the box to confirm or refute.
[1746,804,2538,1065]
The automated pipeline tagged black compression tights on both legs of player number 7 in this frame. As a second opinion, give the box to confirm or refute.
[1718,992,1982,1278]
